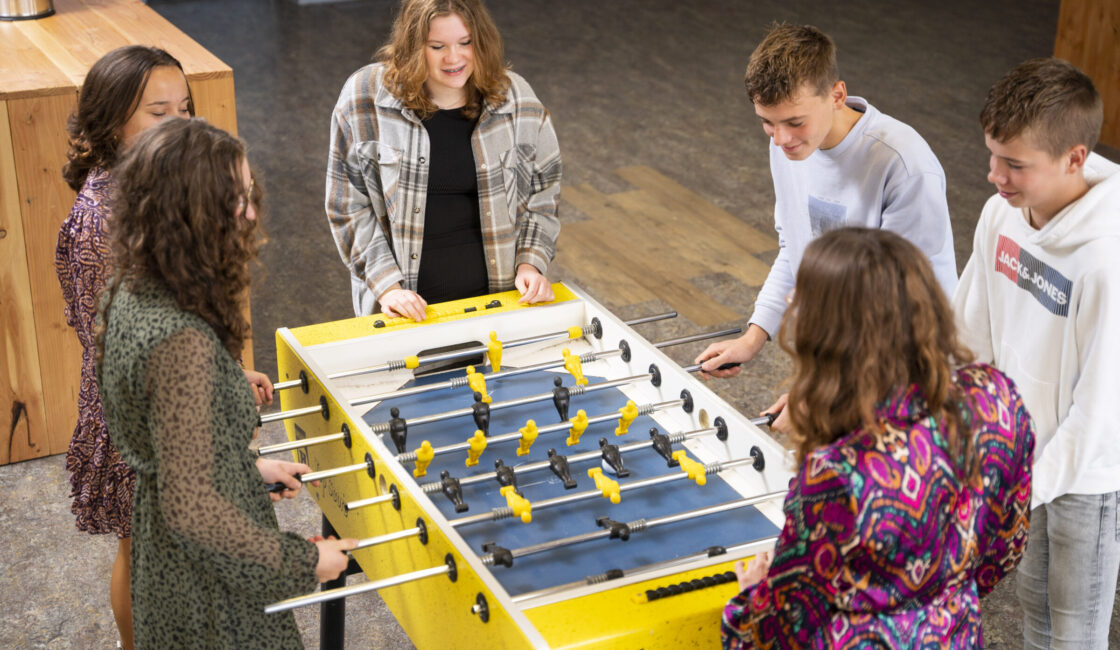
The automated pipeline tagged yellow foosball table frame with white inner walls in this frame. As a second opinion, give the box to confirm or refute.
[265,284,792,648]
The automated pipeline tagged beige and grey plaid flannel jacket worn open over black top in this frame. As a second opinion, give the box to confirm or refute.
[326,63,561,305]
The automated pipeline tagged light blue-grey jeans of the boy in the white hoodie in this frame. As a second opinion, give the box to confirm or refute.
[1017,492,1120,650]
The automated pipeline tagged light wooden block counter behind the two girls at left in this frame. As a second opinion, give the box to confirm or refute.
[0,0,243,464]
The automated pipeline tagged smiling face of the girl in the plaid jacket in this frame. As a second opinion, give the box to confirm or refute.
[424,13,475,109]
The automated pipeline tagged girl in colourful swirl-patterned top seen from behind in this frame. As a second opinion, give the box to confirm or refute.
[722,228,1034,648]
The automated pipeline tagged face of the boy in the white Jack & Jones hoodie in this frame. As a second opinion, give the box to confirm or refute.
[984,133,1088,228]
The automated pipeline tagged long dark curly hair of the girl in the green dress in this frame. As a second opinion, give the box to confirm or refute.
[97,118,261,360]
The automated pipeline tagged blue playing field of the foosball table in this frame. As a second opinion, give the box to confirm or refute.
[363,363,777,596]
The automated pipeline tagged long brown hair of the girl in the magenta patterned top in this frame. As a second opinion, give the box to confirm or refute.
[778,228,979,481]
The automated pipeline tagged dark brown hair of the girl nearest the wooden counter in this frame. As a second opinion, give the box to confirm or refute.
[63,45,195,192]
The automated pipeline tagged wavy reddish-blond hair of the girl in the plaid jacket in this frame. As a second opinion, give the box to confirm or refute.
[374,0,510,119]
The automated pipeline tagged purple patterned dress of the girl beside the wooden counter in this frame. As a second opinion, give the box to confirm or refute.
[55,168,136,539]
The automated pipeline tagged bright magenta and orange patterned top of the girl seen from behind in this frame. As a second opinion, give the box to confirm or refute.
[721,364,1035,648]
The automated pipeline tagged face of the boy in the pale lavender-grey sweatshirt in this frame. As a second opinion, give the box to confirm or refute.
[755,82,847,160]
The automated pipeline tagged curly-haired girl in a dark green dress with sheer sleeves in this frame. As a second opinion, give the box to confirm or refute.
[97,119,356,650]
